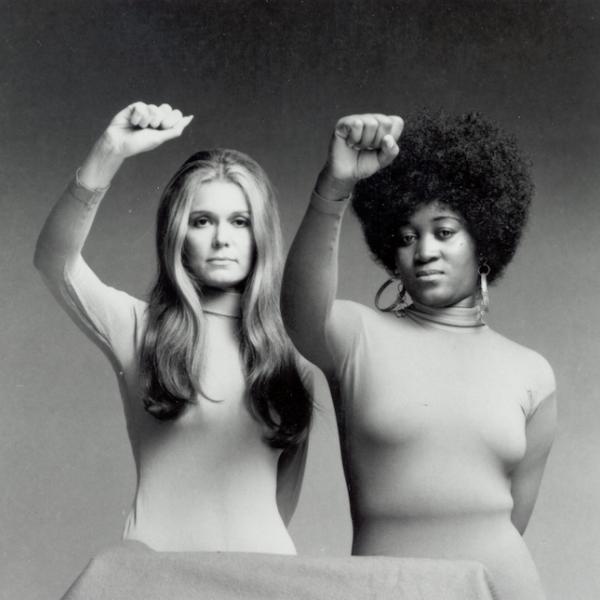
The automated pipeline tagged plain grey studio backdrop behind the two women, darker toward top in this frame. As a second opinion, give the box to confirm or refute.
[0,0,600,600]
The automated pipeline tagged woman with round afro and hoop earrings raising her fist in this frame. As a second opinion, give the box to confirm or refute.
[282,114,556,600]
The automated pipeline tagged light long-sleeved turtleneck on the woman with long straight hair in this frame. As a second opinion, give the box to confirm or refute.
[36,181,311,554]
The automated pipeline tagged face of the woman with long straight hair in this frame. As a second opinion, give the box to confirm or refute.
[185,180,255,290]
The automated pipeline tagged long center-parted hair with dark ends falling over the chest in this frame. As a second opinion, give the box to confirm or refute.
[140,149,312,447]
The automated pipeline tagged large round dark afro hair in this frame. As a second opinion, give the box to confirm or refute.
[352,113,533,282]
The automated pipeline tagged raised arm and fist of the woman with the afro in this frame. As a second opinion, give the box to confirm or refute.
[281,114,403,372]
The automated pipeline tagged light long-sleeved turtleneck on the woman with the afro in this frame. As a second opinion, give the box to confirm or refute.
[282,190,555,600]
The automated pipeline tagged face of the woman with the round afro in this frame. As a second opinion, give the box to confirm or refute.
[396,203,478,308]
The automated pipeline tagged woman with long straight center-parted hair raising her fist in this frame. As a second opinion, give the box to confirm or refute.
[35,102,312,554]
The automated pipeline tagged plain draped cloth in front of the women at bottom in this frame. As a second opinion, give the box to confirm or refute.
[62,542,497,600]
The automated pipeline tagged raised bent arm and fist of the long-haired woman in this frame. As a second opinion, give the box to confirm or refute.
[34,102,191,356]
